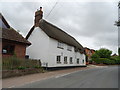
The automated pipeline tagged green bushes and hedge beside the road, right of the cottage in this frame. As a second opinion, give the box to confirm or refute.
[91,48,120,65]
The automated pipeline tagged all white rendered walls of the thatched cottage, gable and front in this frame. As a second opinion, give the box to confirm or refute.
[26,27,86,67]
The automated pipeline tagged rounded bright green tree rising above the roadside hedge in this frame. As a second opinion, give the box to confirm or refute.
[96,48,112,58]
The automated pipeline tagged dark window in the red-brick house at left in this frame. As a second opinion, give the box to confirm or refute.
[2,45,15,54]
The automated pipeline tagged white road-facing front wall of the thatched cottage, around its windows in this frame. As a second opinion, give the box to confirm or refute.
[49,38,86,67]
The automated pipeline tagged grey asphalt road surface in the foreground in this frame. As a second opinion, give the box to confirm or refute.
[16,66,118,88]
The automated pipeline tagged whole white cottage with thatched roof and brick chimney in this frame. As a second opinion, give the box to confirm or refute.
[26,9,86,67]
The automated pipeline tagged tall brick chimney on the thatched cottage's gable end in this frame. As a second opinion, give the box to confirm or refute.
[34,7,43,27]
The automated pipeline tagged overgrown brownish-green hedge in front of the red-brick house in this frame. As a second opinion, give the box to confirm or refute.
[2,56,41,70]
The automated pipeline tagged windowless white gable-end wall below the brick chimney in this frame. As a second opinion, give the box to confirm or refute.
[26,27,49,66]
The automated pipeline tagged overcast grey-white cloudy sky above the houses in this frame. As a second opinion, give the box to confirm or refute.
[0,0,118,54]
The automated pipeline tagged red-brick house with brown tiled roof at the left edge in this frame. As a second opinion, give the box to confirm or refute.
[0,13,31,58]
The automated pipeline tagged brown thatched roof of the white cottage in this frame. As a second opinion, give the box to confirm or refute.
[26,19,84,53]
